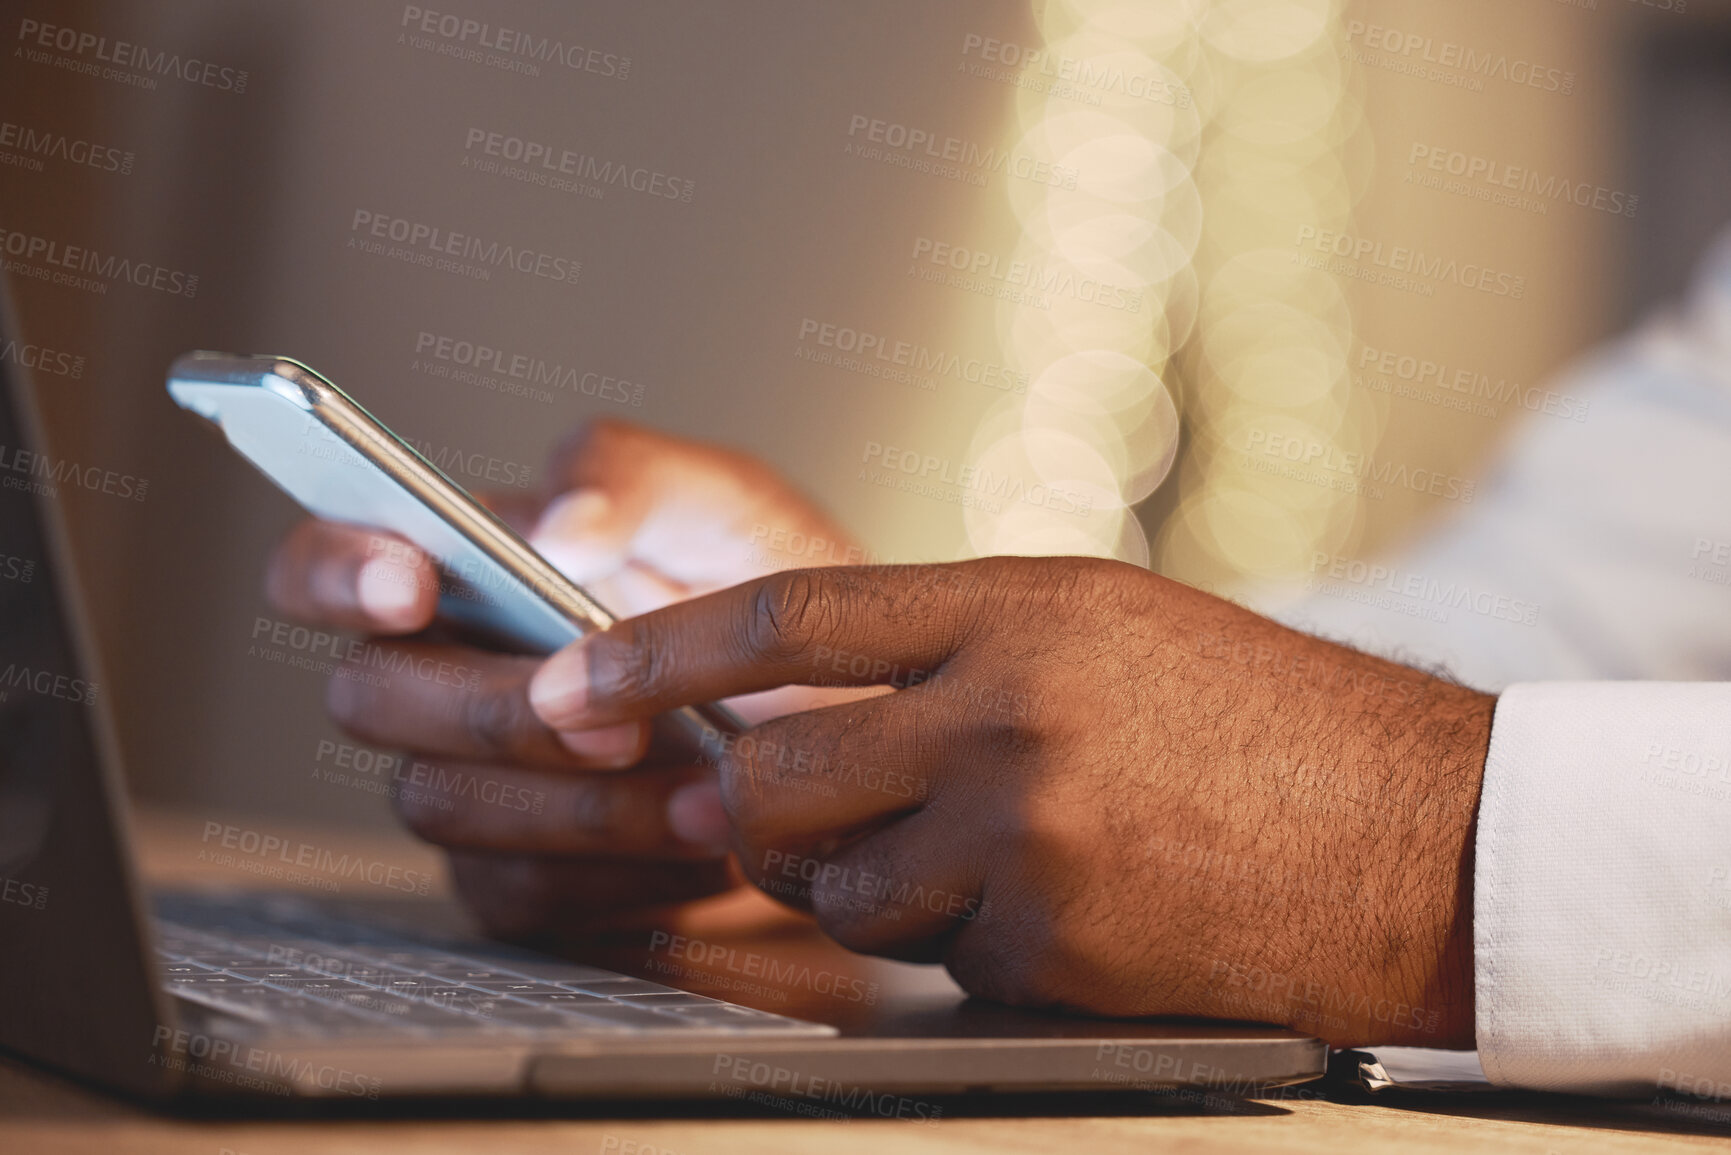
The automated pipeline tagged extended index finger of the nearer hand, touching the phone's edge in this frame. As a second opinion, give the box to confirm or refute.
[530,561,988,731]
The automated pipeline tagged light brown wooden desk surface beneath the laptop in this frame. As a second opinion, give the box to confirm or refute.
[0,816,1731,1155]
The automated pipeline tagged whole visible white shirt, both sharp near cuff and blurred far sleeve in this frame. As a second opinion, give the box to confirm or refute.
[1246,236,1731,1101]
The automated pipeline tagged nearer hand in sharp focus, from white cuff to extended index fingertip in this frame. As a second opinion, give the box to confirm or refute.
[530,558,1494,1046]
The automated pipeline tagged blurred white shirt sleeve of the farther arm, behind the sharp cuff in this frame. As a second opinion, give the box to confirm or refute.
[1258,234,1731,691]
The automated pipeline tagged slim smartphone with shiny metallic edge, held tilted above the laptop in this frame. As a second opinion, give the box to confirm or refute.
[168,352,744,753]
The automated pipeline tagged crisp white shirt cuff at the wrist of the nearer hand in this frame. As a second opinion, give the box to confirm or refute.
[1473,682,1731,1096]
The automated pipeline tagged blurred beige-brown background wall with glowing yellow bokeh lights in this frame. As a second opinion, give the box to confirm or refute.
[0,0,1731,823]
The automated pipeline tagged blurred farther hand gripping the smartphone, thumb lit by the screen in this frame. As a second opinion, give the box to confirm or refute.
[267,421,859,935]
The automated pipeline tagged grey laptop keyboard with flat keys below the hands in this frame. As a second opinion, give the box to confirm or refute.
[156,895,834,1037]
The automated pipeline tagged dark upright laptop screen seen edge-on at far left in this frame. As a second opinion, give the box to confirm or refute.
[0,320,166,1093]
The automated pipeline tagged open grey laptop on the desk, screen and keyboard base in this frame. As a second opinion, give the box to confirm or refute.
[0,287,1328,1119]
